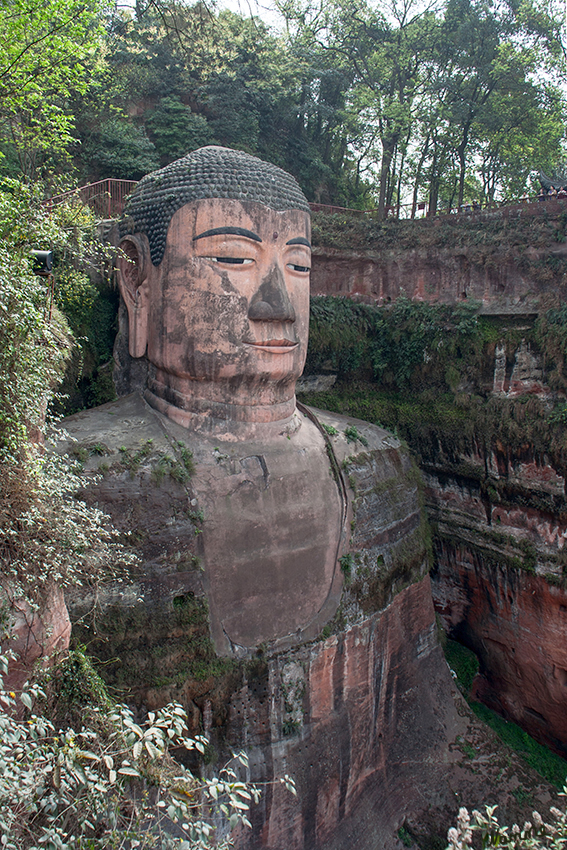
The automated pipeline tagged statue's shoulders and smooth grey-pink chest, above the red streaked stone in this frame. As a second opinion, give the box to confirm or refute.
[59,395,425,656]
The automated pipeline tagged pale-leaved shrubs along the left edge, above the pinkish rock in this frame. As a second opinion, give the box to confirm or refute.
[0,179,125,604]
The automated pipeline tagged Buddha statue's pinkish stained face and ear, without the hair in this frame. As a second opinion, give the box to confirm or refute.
[121,199,311,403]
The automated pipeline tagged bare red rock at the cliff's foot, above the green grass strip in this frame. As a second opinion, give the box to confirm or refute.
[434,543,567,757]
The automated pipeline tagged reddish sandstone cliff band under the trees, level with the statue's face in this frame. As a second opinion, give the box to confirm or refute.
[311,201,567,315]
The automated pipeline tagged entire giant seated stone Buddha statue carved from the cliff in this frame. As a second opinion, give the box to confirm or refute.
[55,147,448,850]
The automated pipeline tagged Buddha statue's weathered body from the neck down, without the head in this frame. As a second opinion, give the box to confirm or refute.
[55,394,462,850]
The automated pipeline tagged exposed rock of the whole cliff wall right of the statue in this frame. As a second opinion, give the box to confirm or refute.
[306,217,567,755]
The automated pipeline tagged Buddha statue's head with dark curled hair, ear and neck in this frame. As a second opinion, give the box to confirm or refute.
[118,146,311,426]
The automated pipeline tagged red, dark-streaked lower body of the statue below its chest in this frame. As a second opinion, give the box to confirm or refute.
[228,578,462,850]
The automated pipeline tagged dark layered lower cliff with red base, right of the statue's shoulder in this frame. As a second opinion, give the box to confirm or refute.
[422,332,567,756]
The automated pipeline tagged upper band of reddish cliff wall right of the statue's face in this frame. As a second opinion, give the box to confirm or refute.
[311,201,567,315]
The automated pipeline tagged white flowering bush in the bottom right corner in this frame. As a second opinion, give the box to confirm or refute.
[446,800,567,850]
